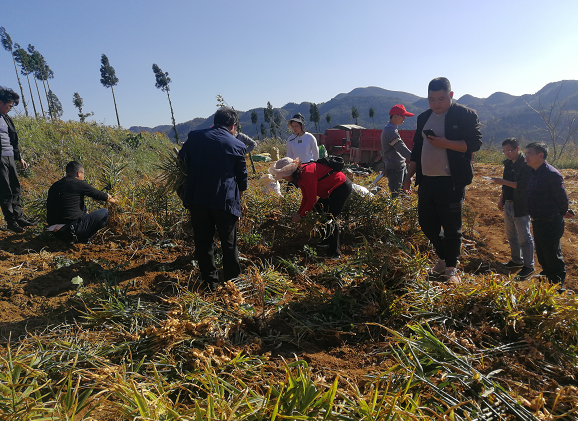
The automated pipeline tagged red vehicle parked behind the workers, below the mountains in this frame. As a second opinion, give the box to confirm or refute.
[318,124,415,171]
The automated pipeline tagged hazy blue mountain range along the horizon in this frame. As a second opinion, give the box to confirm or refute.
[130,80,578,145]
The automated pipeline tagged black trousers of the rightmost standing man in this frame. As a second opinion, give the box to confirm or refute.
[532,215,566,284]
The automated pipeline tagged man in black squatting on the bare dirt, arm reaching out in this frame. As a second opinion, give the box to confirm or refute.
[46,161,118,243]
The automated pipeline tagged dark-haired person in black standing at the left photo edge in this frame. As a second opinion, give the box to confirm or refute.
[0,87,34,233]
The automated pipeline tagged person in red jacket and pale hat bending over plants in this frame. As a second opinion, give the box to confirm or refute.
[269,157,352,259]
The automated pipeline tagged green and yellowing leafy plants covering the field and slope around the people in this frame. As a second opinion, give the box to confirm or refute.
[0,117,578,421]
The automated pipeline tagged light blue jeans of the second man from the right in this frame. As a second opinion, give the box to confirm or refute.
[504,200,534,269]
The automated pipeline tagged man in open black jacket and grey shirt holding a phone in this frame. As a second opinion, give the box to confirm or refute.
[403,77,482,282]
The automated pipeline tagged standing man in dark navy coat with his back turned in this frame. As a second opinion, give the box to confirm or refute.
[179,107,248,289]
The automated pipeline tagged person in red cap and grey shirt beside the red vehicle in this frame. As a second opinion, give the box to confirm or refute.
[373,104,415,199]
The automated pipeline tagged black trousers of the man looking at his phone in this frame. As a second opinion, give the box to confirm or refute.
[417,176,466,267]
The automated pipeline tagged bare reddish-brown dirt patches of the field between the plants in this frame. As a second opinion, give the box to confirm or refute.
[0,164,578,384]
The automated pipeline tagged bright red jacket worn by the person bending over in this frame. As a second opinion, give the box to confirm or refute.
[297,162,346,216]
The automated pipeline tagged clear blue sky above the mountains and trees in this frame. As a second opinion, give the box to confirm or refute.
[0,0,578,128]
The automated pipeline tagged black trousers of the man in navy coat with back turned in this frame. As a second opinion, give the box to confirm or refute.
[189,205,241,282]
